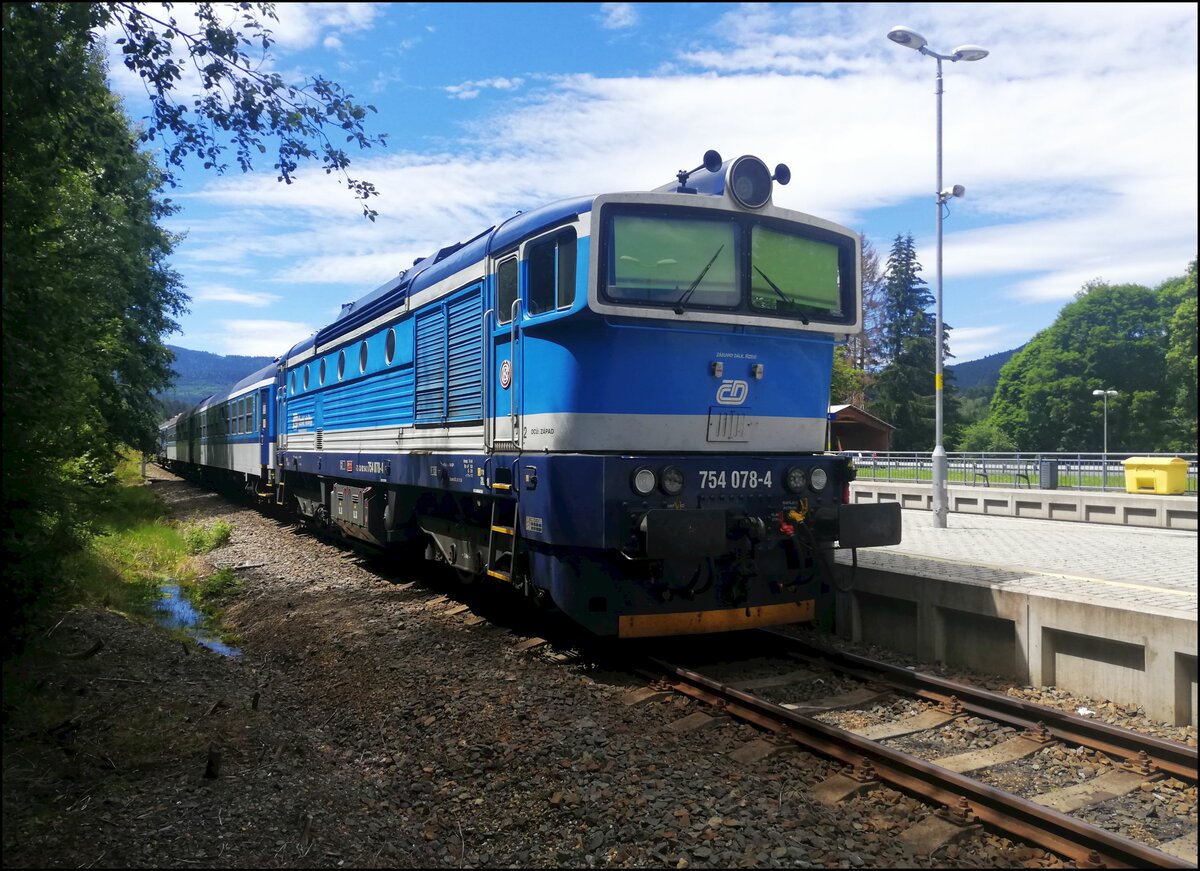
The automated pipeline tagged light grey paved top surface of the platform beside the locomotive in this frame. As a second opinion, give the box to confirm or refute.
[836,510,1198,615]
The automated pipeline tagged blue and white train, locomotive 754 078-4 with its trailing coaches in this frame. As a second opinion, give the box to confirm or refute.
[154,151,900,637]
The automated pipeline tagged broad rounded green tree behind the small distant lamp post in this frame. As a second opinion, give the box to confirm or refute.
[988,281,1180,451]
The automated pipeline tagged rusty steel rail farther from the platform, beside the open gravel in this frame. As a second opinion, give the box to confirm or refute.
[652,659,1194,869]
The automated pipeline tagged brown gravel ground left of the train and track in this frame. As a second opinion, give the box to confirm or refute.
[4,469,1195,869]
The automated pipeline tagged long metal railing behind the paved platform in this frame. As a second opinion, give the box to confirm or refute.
[839,451,1198,494]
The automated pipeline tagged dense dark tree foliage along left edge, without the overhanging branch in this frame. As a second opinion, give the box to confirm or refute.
[4,5,184,643]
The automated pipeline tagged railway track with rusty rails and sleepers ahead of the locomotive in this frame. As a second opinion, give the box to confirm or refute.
[642,632,1196,867]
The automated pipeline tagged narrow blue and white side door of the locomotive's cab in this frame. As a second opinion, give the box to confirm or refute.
[487,251,522,450]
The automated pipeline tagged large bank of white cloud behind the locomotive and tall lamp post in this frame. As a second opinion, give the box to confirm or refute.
[157,4,1198,360]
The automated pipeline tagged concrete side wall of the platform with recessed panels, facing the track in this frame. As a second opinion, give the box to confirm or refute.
[836,563,1198,726]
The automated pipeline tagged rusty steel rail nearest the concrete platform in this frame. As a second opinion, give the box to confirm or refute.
[762,630,1196,780]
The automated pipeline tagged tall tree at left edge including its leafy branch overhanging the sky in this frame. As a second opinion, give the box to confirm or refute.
[2,2,382,654]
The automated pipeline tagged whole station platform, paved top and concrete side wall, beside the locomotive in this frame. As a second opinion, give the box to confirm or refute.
[836,509,1198,725]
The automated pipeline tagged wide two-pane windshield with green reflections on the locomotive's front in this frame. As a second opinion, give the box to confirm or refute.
[604,210,853,324]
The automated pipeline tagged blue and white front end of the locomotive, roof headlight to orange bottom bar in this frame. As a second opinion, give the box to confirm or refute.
[487,157,899,636]
